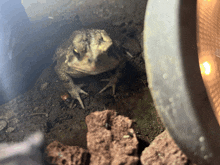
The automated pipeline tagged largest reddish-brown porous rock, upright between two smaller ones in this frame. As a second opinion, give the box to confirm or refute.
[86,110,139,165]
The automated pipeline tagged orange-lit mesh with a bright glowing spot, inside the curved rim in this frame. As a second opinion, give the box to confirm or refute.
[197,0,220,123]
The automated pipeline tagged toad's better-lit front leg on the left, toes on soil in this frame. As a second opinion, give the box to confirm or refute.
[54,66,88,109]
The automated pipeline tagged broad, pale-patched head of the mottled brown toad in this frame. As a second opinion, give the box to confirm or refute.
[65,29,119,75]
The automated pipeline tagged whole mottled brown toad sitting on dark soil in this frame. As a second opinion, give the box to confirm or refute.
[54,29,124,108]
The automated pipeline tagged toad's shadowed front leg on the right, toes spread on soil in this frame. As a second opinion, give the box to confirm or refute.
[99,61,126,95]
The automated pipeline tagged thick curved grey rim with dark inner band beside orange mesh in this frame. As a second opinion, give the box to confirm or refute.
[144,0,220,164]
